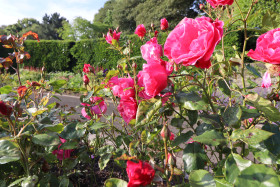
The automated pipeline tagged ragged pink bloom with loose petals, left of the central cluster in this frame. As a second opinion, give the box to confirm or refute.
[81,97,107,119]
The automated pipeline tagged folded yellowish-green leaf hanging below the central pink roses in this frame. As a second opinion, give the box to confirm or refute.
[136,99,162,126]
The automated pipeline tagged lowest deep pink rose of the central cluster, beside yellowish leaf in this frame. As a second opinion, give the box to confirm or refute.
[118,96,137,123]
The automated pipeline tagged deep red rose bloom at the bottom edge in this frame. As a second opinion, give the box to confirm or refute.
[126,160,155,187]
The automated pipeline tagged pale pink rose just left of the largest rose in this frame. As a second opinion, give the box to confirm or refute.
[141,37,163,63]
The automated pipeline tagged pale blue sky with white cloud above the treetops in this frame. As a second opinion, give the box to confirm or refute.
[0,0,107,26]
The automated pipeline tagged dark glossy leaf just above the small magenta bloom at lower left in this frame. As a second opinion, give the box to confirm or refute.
[60,122,86,140]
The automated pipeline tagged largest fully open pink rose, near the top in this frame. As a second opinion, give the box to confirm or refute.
[164,17,224,68]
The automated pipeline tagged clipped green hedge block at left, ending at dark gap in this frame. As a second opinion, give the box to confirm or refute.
[24,40,75,72]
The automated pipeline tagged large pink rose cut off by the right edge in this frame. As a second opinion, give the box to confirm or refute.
[247,28,280,65]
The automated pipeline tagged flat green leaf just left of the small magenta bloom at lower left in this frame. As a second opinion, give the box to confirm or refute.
[32,133,61,146]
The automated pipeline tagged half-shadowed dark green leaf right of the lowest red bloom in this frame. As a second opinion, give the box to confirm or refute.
[183,142,207,172]
